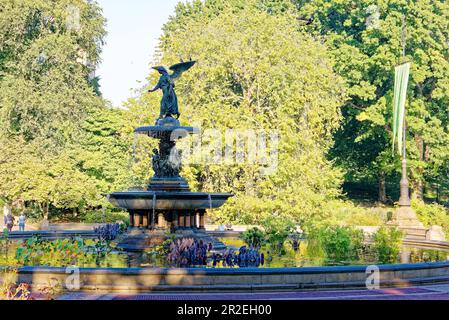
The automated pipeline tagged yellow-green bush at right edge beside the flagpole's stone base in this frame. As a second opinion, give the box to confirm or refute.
[412,199,449,234]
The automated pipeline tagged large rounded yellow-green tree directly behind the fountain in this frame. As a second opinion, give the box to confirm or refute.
[130,1,344,223]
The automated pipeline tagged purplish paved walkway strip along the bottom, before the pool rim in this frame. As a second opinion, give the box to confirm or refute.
[58,284,449,300]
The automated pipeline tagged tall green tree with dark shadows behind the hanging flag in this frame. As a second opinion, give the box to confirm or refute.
[297,0,449,198]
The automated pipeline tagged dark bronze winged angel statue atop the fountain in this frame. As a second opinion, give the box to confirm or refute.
[148,60,196,119]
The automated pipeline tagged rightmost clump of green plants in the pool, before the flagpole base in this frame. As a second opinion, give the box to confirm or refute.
[372,227,403,263]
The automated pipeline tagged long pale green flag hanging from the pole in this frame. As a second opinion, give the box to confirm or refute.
[393,62,410,155]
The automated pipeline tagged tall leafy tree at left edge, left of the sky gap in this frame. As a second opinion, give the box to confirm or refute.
[0,0,124,215]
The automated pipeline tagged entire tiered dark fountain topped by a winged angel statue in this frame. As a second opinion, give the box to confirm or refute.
[108,61,232,244]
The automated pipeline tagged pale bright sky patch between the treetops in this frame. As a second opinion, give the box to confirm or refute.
[96,0,179,107]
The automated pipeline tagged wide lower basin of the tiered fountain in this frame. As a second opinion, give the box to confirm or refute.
[109,191,233,210]
